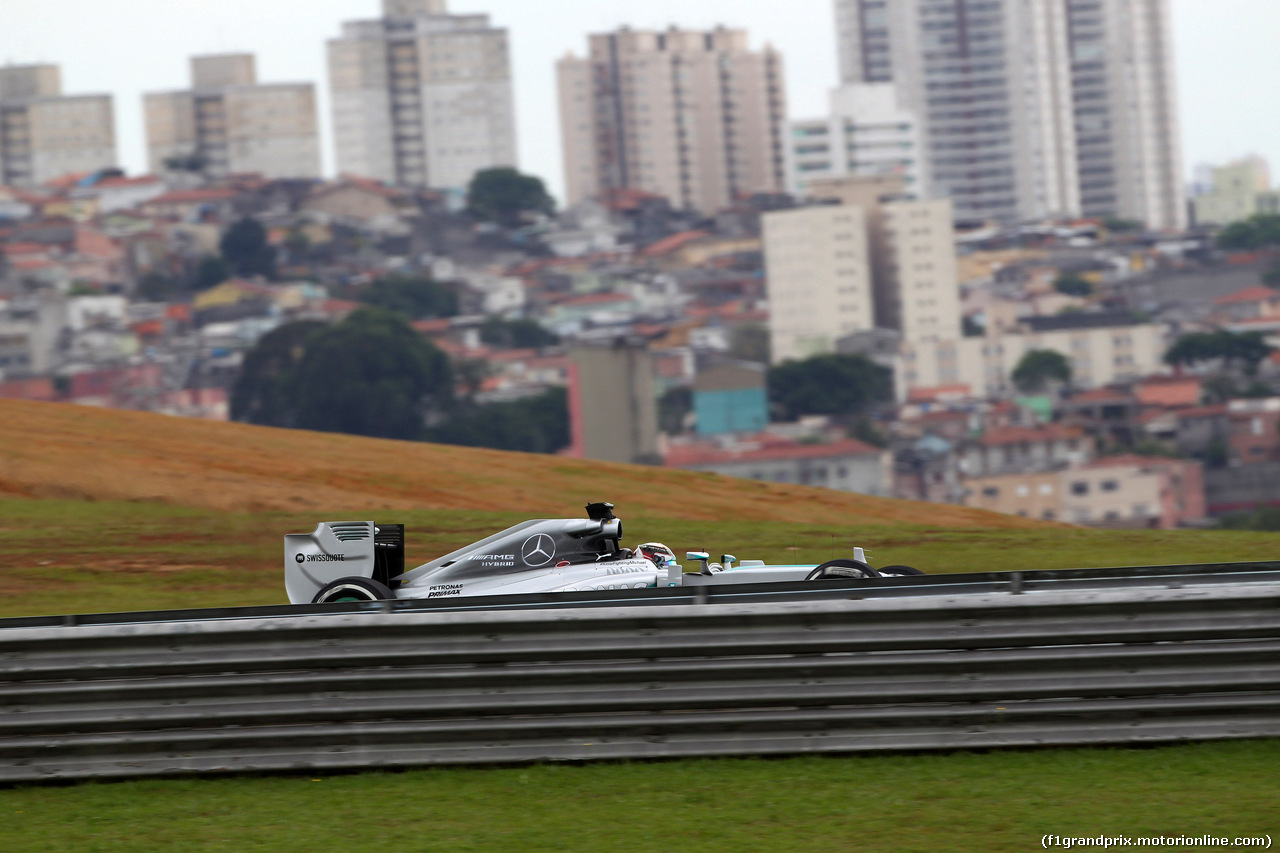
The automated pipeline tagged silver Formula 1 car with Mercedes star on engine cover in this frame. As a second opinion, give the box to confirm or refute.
[284,503,923,605]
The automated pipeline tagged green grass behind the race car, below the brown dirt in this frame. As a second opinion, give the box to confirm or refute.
[0,500,1280,616]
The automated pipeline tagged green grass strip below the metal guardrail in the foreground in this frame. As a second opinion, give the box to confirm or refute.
[0,740,1280,853]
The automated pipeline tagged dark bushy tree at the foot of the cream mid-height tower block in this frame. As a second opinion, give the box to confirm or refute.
[768,355,893,420]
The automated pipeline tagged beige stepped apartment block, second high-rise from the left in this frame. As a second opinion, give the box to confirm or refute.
[143,54,320,178]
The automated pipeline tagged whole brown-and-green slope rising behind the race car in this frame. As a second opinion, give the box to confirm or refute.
[0,401,1277,616]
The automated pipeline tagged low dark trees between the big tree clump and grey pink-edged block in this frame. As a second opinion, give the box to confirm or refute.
[426,388,571,453]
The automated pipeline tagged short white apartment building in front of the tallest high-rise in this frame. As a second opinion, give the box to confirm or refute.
[786,83,925,197]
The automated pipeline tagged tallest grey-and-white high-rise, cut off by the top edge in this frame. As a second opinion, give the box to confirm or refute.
[836,0,1185,228]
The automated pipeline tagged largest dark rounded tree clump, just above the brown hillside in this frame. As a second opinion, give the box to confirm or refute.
[232,307,453,439]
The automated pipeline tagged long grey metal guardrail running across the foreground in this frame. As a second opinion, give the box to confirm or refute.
[0,564,1280,783]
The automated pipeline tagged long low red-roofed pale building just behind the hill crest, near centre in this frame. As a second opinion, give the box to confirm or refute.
[664,433,893,494]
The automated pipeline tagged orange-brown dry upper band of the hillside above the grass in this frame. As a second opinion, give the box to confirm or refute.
[0,400,1039,528]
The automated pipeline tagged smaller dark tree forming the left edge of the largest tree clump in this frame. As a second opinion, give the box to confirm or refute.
[230,320,328,427]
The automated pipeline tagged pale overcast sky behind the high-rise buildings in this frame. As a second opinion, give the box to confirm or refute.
[0,0,1280,202]
